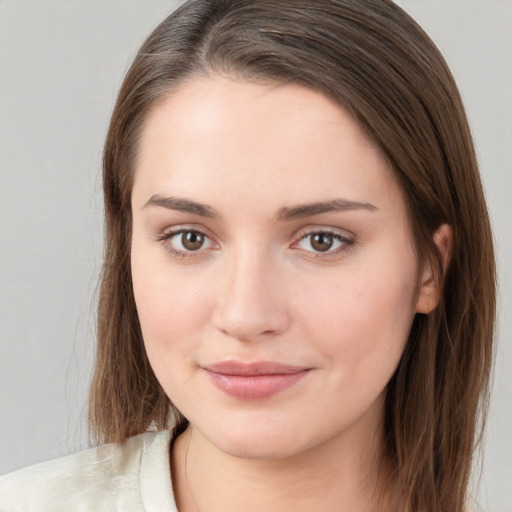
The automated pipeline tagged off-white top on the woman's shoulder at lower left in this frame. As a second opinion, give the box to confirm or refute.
[0,431,178,512]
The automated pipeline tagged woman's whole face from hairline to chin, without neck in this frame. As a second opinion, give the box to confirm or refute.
[131,78,426,458]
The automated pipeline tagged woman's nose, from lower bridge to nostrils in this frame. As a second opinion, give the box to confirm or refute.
[213,247,290,341]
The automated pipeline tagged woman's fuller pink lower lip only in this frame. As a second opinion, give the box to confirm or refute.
[206,370,309,400]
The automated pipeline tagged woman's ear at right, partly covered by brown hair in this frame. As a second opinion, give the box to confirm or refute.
[416,224,453,314]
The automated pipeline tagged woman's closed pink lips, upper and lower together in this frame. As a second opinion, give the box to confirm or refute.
[203,361,310,400]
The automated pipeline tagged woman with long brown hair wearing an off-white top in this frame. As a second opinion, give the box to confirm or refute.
[2,0,495,512]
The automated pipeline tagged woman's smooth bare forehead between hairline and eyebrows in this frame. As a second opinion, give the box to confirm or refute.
[133,77,401,214]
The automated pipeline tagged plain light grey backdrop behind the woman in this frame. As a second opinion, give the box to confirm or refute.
[0,0,512,512]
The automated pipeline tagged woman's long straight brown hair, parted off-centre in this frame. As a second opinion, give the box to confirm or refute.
[90,0,495,512]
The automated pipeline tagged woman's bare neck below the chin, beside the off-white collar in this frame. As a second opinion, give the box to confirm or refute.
[172,402,385,512]
